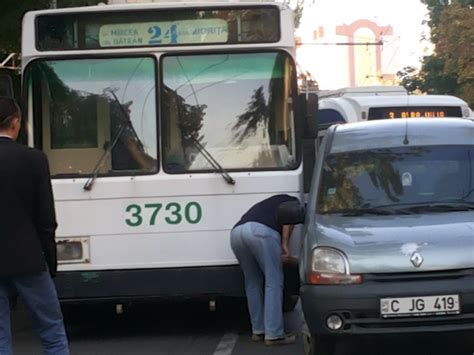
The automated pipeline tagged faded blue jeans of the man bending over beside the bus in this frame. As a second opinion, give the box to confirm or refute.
[230,222,284,339]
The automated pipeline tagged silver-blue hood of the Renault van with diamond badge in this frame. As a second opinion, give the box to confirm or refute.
[309,211,474,274]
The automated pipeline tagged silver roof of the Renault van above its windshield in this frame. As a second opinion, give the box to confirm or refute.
[330,118,474,153]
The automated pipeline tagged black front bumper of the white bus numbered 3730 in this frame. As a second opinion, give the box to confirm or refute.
[54,265,299,302]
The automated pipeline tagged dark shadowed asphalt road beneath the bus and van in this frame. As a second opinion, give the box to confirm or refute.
[8,300,474,355]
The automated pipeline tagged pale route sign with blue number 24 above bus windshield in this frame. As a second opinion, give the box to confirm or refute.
[99,19,229,47]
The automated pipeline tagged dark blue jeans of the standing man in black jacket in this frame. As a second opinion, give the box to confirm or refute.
[0,272,69,355]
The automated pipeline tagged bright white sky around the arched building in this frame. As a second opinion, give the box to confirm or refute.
[296,0,432,89]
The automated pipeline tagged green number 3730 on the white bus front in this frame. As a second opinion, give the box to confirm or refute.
[125,202,202,227]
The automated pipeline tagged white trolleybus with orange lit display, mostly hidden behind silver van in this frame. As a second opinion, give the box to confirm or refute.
[318,86,472,129]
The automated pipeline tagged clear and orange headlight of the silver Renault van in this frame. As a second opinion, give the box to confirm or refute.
[309,247,362,285]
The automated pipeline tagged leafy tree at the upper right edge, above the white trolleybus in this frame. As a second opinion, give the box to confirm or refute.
[397,0,474,106]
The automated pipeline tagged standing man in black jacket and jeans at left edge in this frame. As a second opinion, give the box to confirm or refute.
[0,97,69,355]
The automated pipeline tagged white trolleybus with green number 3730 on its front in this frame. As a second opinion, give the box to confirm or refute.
[22,2,316,301]
